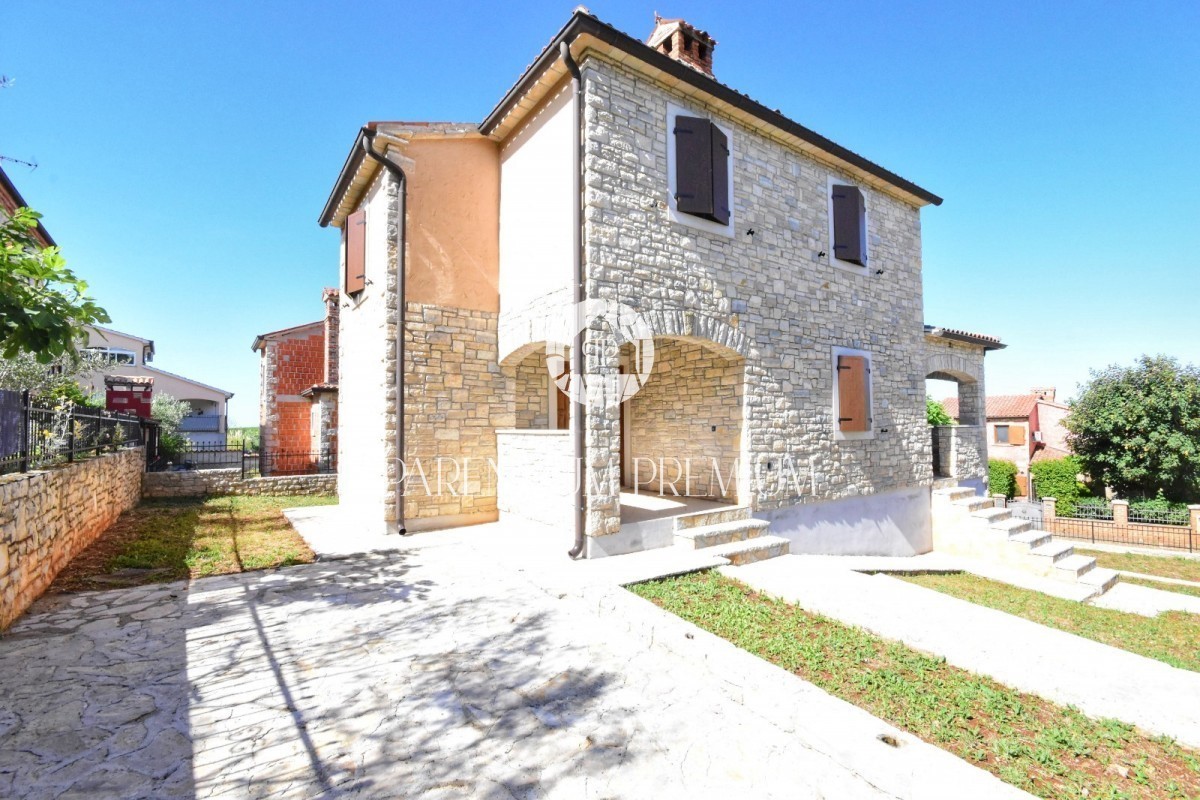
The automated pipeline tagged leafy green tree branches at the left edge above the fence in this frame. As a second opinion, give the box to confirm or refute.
[0,207,109,363]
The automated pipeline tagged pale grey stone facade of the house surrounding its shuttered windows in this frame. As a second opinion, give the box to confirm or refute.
[583,56,932,544]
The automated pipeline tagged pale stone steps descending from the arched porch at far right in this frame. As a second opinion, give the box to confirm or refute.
[932,487,1120,600]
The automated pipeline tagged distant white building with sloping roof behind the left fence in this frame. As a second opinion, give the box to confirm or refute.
[80,325,233,445]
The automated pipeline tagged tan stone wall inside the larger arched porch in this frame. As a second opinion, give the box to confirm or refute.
[625,339,744,503]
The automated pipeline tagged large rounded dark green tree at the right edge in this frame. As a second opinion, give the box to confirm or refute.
[1064,355,1200,501]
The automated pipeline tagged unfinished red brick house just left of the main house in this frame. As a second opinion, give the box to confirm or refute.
[251,289,338,473]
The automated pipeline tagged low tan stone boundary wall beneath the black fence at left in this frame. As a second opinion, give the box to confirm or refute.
[0,447,145,630]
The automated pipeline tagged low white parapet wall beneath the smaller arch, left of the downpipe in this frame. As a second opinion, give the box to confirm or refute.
[496,429,575,534]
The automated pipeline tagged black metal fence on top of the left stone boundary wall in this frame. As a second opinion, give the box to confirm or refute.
[0,390,146,474]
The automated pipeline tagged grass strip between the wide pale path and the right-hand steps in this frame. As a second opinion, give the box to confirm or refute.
[896,572,1200,672]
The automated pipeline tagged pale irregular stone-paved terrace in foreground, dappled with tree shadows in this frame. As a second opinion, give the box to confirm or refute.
[0,527,1025,798]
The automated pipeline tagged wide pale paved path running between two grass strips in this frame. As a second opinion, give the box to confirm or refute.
[721,555,1200,747]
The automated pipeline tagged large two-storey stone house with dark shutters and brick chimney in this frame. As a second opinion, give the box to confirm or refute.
[320,10,1002,557]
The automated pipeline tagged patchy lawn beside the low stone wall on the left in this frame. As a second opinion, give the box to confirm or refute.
[52,497,337,591]
